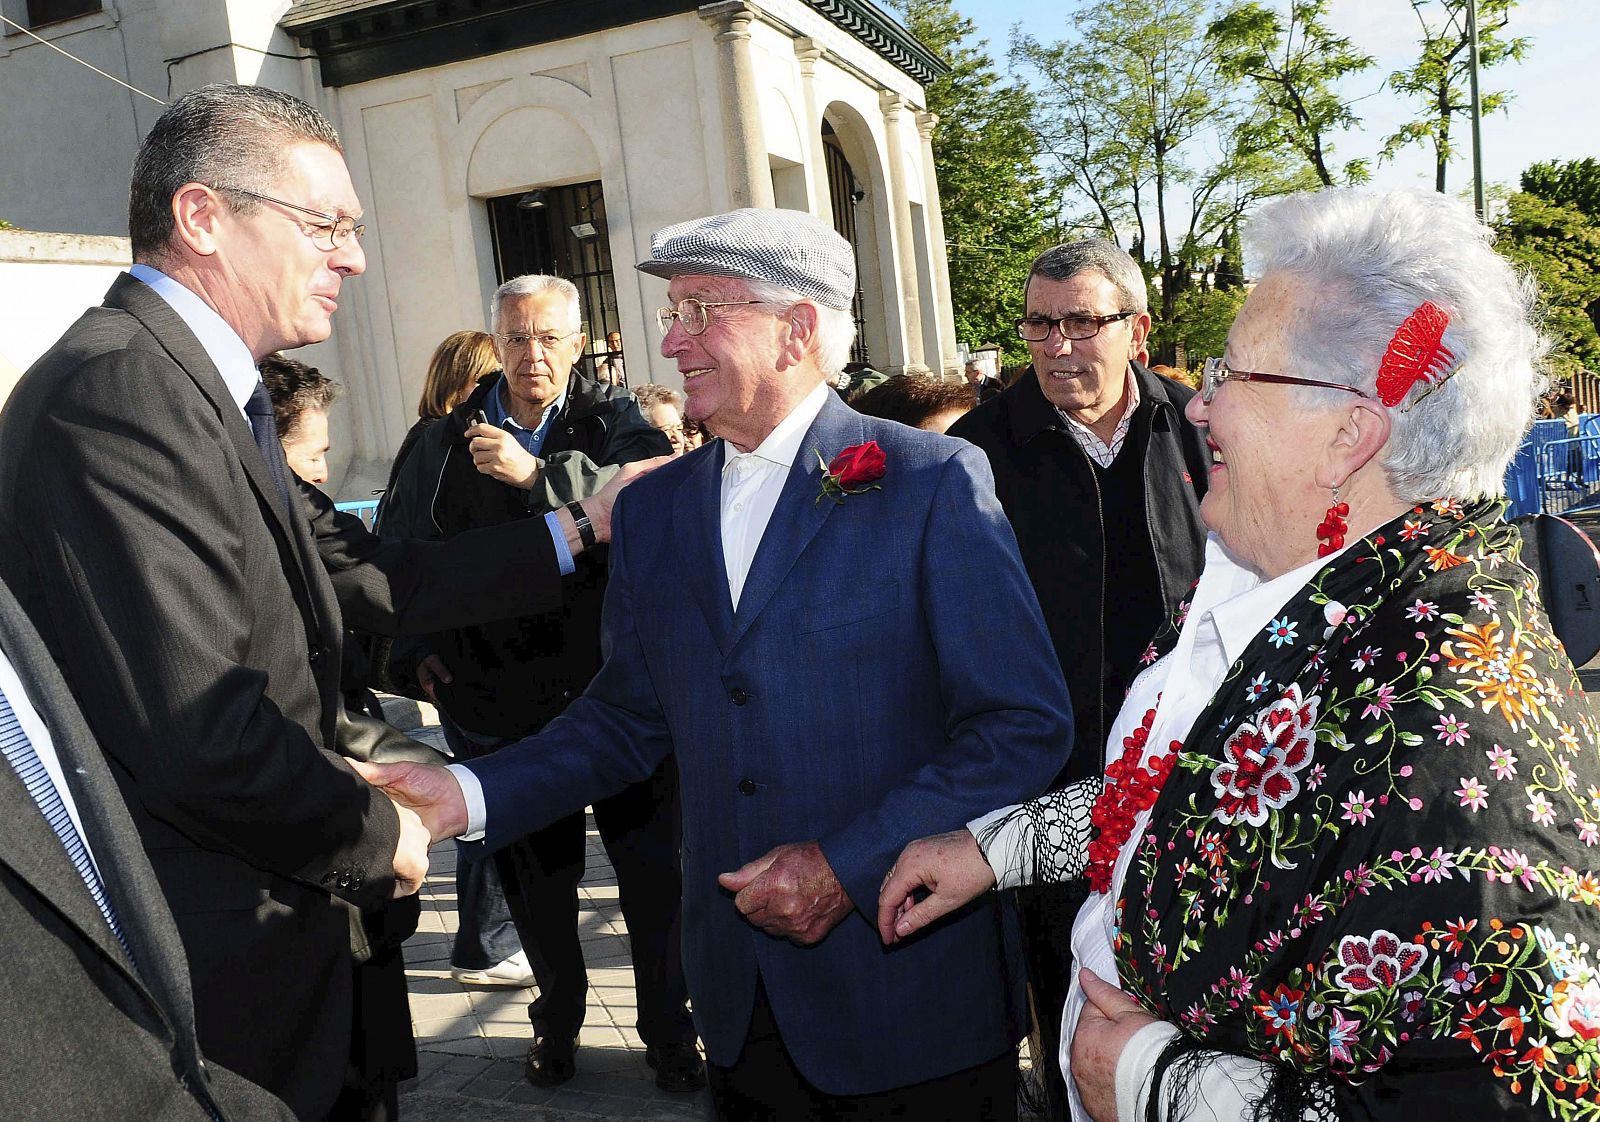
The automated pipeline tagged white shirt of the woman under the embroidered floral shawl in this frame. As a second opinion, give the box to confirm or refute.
[970,533,1331,1122]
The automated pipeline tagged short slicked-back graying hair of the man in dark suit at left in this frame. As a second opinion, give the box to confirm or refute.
[128,82,344,261]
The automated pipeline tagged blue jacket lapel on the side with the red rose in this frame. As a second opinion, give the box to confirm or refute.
[732,392,866,643]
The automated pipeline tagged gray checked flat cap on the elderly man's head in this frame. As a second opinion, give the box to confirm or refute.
[638,208,856,309]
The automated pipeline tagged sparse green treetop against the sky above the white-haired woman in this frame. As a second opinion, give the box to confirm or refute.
[1206,0,1374,187]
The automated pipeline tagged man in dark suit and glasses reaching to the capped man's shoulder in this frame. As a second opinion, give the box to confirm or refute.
[0,86,643,1119]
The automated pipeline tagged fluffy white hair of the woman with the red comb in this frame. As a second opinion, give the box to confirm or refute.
[1245,187,1550,503]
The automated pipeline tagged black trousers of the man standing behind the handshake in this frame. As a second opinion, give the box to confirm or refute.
[494,757,694,1045]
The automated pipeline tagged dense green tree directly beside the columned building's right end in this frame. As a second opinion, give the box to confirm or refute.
[898,0,1050,362]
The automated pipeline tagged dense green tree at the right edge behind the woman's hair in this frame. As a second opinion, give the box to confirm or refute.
[1496,160,1600,378]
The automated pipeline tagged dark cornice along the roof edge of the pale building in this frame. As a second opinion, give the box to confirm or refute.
[280,0,949,86]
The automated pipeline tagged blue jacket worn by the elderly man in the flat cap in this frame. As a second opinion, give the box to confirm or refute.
[470,388,1072,1095]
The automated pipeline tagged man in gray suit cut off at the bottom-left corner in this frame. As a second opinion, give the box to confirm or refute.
[0,573,293,1122]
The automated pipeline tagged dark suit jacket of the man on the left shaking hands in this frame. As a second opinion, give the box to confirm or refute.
[0,277,560,1117]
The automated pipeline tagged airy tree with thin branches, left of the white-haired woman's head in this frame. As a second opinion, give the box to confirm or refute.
[1011,0,1317,362]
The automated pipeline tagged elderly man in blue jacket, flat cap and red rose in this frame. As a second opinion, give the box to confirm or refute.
[365,210,1072,1122]
